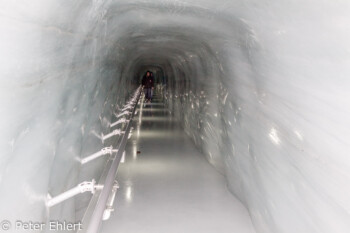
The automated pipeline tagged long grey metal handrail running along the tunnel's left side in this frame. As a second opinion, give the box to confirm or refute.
[78,86,142,233]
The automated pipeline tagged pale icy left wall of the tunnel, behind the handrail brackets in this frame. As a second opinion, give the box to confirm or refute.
[0,1,137,228]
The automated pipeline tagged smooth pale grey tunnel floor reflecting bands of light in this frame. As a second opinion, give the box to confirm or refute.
[101,91,255,233]
